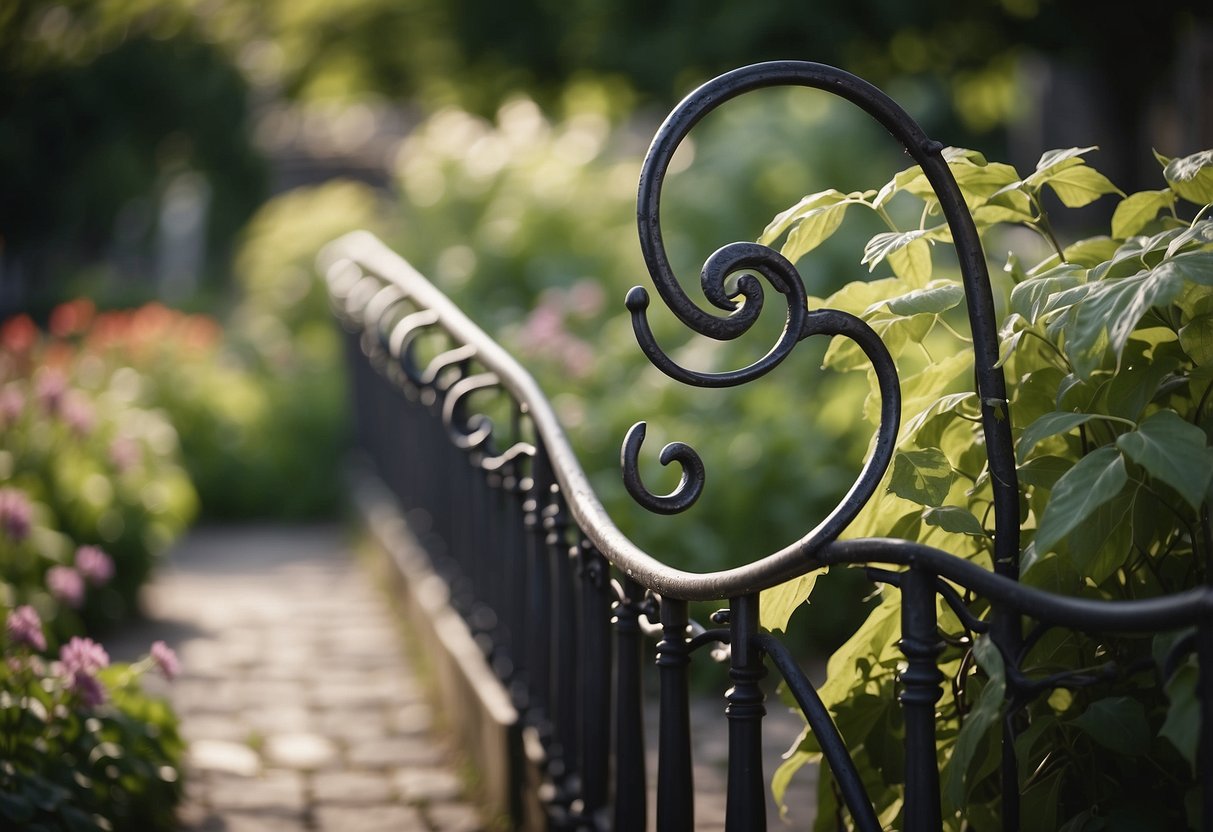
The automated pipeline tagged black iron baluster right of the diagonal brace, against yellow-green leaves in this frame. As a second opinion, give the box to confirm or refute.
[898,568,944,832]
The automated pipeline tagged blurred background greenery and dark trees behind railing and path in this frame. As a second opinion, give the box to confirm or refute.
[0,0,1213,642]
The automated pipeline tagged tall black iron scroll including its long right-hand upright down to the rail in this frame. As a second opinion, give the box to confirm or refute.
[622,61,1019,577]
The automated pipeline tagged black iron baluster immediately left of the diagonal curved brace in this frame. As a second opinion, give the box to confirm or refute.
[724,594,767,832]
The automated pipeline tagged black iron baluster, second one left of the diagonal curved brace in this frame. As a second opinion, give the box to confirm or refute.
[657,598,695,832]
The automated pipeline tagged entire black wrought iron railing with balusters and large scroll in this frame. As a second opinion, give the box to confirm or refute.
[321,62,1213,832]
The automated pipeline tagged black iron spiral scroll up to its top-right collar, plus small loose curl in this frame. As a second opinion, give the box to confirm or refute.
[621,62,941,523]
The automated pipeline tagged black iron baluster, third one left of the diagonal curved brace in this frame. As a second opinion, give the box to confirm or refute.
[613,577,648,832]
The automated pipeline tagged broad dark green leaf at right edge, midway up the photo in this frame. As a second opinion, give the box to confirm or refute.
[1116,410,1213,509]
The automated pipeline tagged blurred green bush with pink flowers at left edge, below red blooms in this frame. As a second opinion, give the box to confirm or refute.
[0,308,198,637]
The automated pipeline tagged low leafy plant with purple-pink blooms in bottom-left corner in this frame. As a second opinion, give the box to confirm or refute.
[0,606,184,832]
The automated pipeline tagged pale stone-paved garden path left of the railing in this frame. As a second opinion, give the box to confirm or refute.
[107,526,492,832]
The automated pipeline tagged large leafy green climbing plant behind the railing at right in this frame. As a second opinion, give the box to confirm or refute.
[761,148,1213,831]
